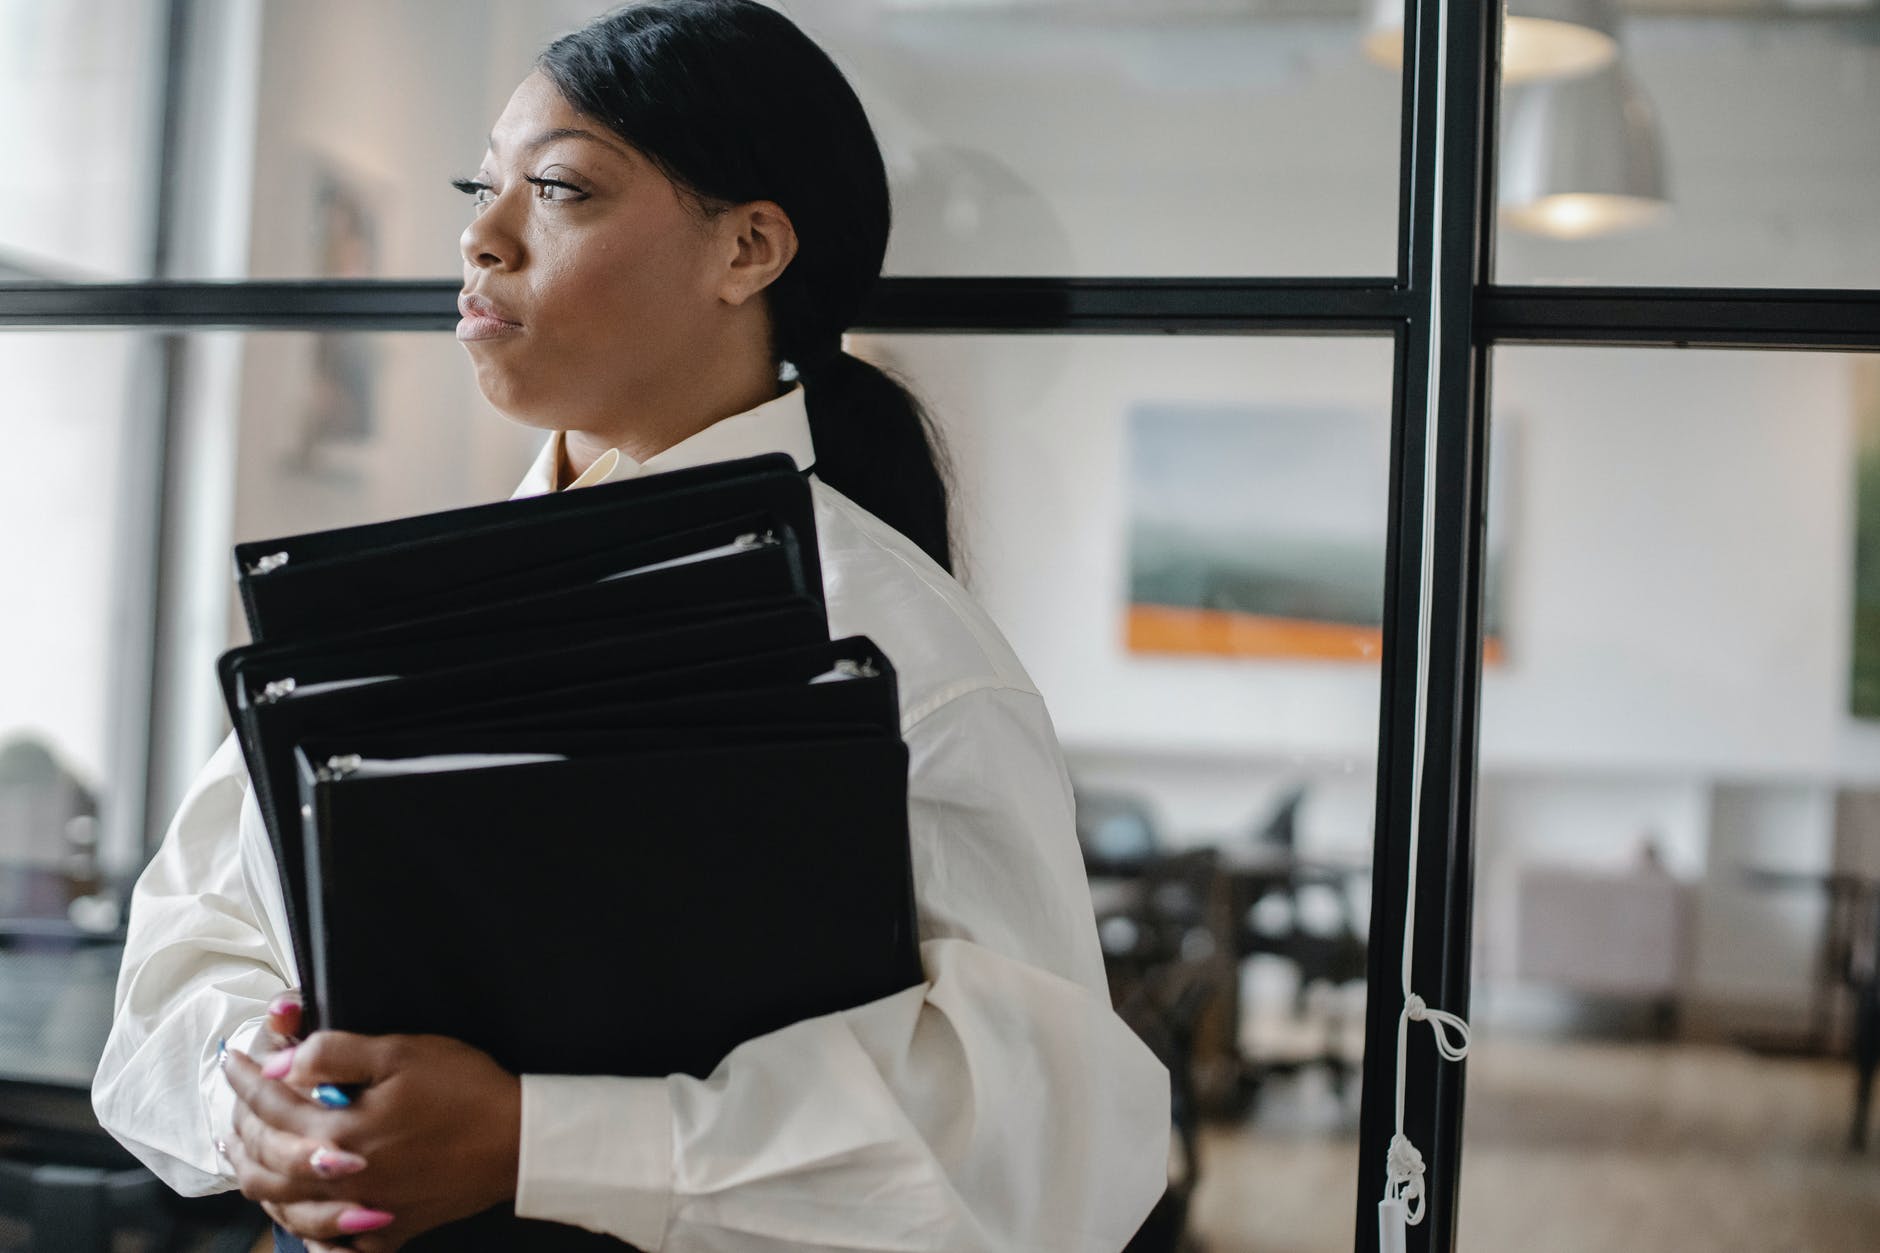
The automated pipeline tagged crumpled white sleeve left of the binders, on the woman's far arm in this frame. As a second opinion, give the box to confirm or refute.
[92,736,295,1197]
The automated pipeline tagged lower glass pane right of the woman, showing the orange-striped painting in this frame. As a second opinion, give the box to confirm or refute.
[855,335,1391,1249]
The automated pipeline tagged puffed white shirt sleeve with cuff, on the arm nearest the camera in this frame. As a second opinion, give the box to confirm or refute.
[515,687,1169,1253]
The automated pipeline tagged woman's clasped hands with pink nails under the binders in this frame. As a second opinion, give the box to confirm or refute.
[227,1031,523,1253]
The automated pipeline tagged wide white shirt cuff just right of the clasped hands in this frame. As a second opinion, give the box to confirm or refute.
[515,1074,673,1253]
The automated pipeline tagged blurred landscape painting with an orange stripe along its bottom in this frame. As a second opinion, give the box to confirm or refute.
[1124,401,1512,664]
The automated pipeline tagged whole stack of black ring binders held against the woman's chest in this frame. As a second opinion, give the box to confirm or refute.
[220,453,921,1249]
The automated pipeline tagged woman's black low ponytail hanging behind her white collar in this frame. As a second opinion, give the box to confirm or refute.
[803,352,953,574]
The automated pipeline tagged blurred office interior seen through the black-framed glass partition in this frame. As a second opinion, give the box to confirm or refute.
[0,0,1880,1253]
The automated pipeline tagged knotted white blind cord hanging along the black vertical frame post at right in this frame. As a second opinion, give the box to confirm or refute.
[1378,2,1468,1253]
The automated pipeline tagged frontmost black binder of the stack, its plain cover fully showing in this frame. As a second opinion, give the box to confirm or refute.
[297,734,923,1253]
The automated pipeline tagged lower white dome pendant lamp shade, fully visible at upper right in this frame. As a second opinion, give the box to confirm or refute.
[1496,64,1669,239]
